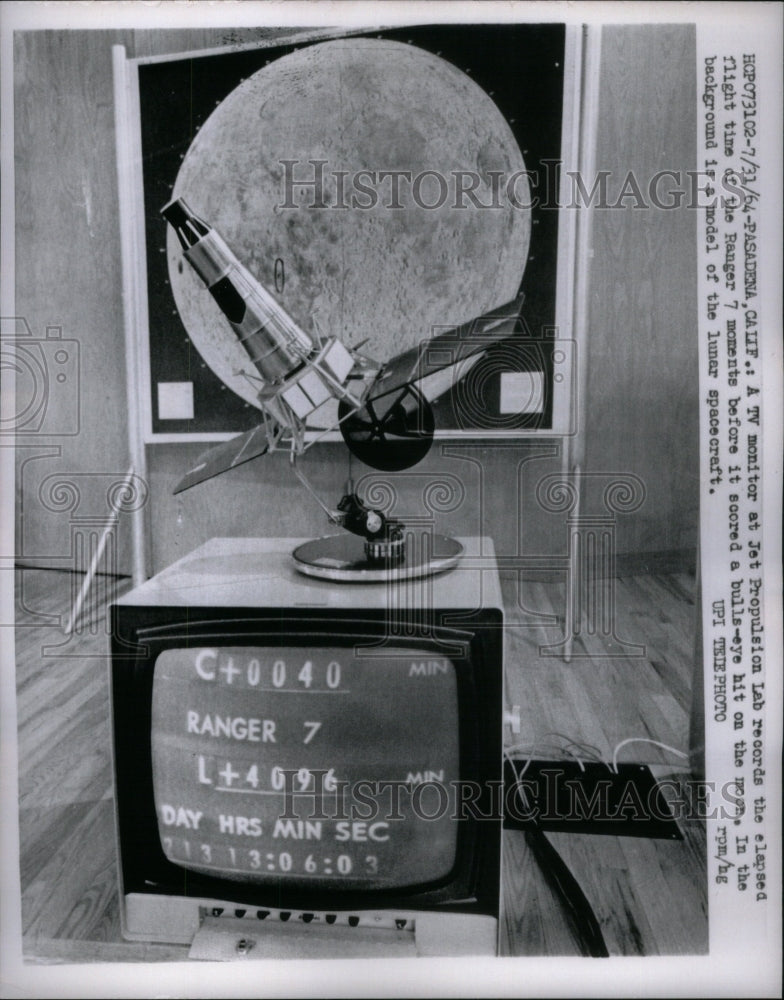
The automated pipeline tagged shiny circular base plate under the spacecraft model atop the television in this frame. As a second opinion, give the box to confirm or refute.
[293,531,463,583]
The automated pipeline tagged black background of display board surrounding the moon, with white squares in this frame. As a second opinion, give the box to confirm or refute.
[133,24,565,437]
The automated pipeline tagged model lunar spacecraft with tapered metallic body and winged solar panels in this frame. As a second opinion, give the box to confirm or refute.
[161,198,523,559]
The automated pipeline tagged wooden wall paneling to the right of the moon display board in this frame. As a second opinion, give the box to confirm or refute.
[585,25,699,552]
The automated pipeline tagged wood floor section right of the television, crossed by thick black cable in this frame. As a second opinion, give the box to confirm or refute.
[501,574,708,955]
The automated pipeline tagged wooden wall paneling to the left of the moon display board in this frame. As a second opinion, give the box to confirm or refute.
[14,31,136,568]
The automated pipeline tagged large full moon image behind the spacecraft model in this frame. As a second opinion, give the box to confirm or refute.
[167,39,531,405]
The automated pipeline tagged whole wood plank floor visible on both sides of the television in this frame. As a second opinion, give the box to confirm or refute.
[9,570,708,962]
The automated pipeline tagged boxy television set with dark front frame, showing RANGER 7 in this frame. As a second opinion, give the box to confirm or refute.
[111,538,503,958]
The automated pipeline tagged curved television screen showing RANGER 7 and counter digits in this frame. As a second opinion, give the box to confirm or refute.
[151,646,460,890]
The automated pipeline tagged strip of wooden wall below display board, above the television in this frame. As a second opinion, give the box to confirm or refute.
[148,441,566,572]
